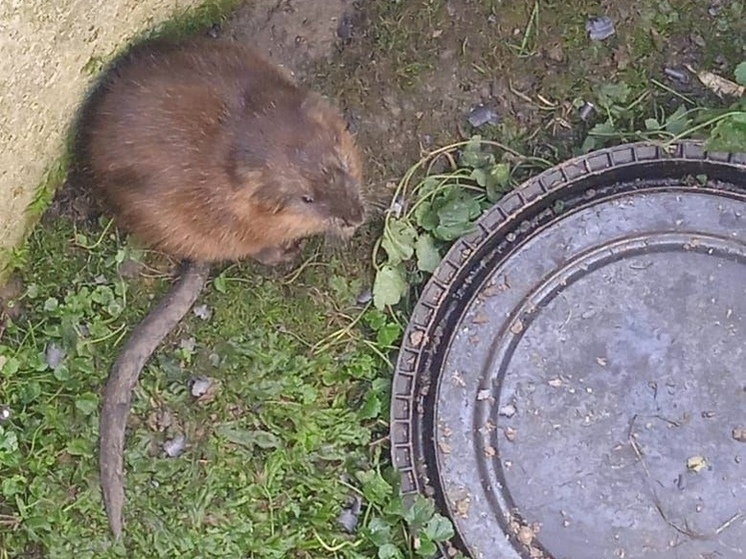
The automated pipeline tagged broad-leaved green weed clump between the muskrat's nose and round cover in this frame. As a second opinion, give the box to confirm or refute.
[373,136,551,309]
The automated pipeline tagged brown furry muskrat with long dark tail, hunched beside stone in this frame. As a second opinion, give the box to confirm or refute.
[79,39,365,538]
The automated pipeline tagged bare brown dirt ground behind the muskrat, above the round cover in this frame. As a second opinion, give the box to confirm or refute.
[215,0,746,205]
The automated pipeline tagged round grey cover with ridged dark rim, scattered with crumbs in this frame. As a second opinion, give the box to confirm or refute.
[391,142,746,559]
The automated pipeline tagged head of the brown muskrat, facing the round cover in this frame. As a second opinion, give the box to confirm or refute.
[230,94,365,241]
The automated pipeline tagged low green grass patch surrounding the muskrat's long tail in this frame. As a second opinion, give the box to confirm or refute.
[0,219,442,557]
